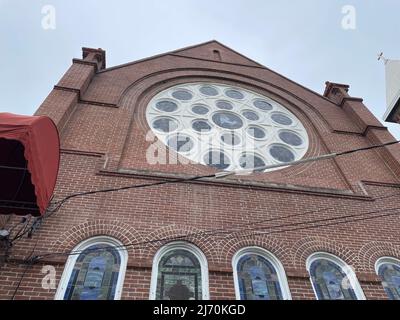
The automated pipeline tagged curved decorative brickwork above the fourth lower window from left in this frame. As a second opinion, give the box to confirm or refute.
[292,236,360,269]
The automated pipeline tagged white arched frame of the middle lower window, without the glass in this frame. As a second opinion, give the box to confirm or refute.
[232,247,292,300]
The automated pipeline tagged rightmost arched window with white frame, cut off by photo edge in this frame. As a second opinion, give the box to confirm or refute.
[375,257,400,300]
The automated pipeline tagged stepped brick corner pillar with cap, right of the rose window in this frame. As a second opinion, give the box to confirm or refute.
[324,82,400,178]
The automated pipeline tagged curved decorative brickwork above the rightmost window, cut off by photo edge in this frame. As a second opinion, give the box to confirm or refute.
[358,241,400,273]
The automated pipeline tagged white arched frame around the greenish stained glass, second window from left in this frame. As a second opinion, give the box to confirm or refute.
[149,241,210,300]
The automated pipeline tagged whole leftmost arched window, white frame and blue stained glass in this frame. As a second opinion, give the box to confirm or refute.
[55,237,127,300]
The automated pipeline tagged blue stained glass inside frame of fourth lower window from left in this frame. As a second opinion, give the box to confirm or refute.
[310,259,357,300]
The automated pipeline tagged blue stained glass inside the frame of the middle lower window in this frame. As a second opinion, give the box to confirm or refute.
[237,254,283,300]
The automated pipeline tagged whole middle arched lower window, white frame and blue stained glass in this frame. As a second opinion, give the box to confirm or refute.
[232,247,291,300]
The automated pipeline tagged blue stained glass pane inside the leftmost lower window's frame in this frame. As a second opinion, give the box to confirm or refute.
[64,244,121,300]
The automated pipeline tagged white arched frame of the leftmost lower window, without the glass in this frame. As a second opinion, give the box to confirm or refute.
[54,236,128,300]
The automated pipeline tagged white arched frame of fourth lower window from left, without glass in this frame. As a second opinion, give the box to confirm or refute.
[306,252,366,300]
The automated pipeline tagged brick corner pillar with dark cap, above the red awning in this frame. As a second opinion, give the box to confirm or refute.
[35,48,106,133]
